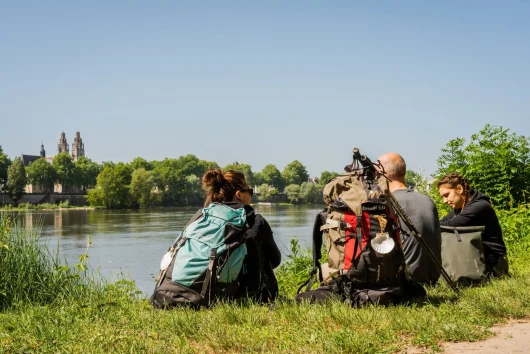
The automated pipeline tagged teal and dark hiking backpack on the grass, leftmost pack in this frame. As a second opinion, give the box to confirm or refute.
[150,203,261,308]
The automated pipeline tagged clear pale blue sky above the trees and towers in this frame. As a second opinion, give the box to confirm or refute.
[0,0,530,175]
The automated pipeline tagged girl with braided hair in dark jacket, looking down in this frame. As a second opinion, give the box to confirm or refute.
[438,173,508,276]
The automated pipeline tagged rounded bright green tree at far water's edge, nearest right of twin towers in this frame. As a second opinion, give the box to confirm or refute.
[87,163,131,209]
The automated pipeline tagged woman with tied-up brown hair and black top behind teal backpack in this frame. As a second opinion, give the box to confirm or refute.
[202,169,281,302]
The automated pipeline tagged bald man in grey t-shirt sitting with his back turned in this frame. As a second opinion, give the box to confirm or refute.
[378,152,442,285]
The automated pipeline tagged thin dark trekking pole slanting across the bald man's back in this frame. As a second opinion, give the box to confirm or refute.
[353,148,460,295]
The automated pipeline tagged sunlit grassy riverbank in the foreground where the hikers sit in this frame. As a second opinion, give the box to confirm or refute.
[0,208,530,353]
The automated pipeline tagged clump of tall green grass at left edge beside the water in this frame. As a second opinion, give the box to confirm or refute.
[0,213,101,310]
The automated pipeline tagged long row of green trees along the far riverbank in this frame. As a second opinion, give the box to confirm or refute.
[0,151,338,209]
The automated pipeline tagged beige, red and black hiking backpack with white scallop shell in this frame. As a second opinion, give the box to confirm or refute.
[297,170,425,305]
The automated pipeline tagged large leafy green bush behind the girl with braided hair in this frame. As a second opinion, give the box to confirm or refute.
[436,124,530,209]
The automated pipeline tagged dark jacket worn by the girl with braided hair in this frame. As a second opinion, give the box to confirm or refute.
[440,190,506,270]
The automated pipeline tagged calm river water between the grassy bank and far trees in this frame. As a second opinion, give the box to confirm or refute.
[20,205,323,295]
